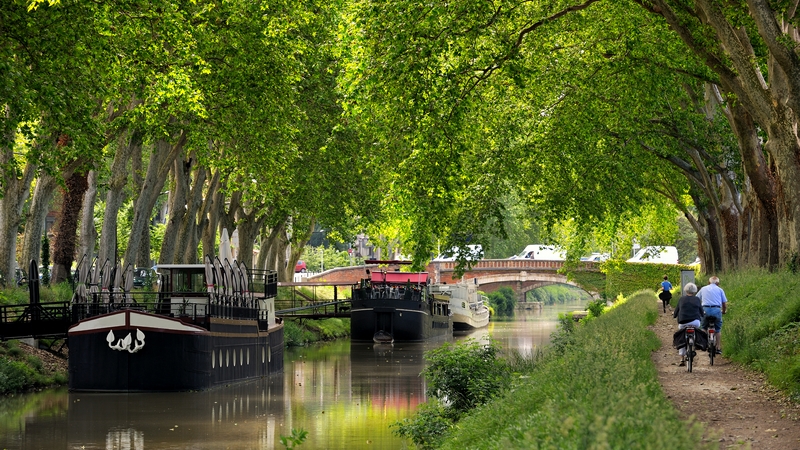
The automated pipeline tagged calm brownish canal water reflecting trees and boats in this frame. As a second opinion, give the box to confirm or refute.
[0,304,584,450]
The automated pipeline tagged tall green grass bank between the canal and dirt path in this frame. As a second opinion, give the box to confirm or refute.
[434,292,714,450]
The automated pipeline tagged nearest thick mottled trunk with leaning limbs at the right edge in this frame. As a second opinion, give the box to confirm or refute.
[640,0,800,267]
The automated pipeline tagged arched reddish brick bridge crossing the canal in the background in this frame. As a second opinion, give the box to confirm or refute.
[308,259,599,302]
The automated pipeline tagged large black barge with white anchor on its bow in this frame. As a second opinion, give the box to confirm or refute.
[68,258,283,392]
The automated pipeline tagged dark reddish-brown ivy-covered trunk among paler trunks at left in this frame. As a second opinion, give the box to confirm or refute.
[50,173,88,283]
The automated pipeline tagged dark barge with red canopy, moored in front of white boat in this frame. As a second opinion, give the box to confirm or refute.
[350,272,453,342]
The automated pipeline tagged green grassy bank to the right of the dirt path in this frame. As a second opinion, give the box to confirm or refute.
[720,270,800,401]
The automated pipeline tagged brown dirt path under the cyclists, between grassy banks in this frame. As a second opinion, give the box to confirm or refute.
[652,301,800,450]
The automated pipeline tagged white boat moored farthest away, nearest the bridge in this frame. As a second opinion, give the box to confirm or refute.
[431,281,489,331]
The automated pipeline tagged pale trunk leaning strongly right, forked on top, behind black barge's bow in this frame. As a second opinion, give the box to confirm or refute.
[125,132,186,268]
